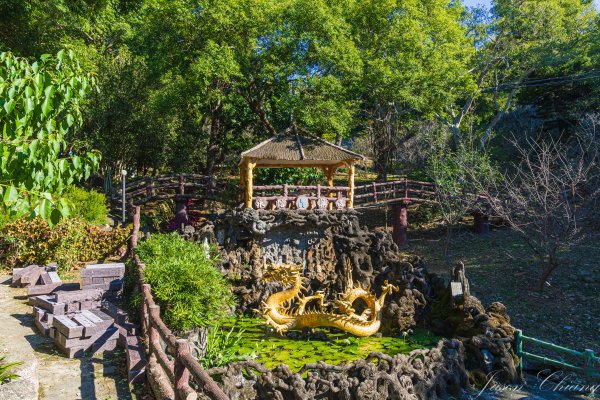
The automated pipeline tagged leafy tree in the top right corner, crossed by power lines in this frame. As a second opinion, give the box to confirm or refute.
[439,0,596,146]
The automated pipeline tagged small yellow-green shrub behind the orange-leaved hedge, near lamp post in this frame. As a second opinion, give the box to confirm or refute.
[64,186,108,225]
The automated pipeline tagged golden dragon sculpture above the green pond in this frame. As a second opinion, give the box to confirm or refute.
[260,264,398,336]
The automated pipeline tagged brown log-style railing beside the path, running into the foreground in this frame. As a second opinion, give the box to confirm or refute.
[130,206,229,400]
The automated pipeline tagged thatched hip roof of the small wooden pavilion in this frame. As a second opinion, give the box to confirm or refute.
[242,125,364,166]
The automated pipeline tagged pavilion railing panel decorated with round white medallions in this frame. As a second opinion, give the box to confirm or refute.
[252,184,350,210]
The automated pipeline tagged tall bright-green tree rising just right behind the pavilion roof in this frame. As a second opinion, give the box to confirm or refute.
[348,0,475,179]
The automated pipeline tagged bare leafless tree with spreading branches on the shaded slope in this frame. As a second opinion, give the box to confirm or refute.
[481,137,600,290]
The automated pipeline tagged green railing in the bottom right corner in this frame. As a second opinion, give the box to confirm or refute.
[515,329,600,379]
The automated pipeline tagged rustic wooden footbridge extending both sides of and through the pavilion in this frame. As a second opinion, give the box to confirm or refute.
[111,174,489,246]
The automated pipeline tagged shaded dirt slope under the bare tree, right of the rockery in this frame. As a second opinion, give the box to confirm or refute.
[361,209,600,354]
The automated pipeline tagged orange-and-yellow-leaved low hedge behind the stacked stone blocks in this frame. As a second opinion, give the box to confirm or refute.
[0,217,130,269]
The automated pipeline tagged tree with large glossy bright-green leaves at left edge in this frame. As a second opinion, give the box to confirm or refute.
[0,50,99,223]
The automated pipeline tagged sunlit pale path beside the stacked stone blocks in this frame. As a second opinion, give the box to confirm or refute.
[0,276,131,400]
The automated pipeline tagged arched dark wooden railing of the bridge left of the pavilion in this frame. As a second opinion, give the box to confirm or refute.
[111,174,228,206]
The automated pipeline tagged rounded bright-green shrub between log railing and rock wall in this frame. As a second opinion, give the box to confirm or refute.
[137,233,233,331]
